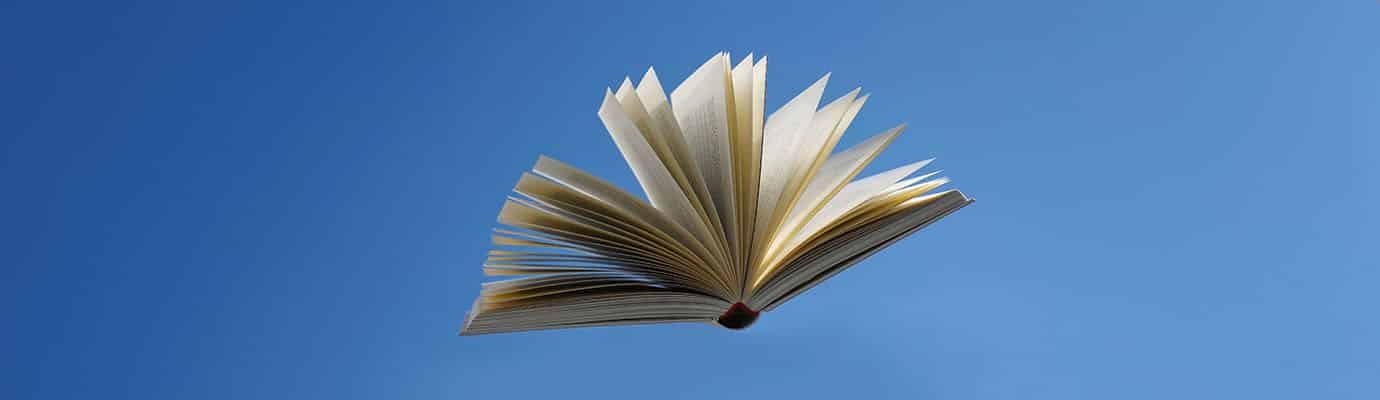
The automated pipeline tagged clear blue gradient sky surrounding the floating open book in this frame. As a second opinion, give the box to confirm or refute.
[0,0,1380,399]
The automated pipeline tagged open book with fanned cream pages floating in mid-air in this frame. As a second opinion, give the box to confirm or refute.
[460,52,973,335]
